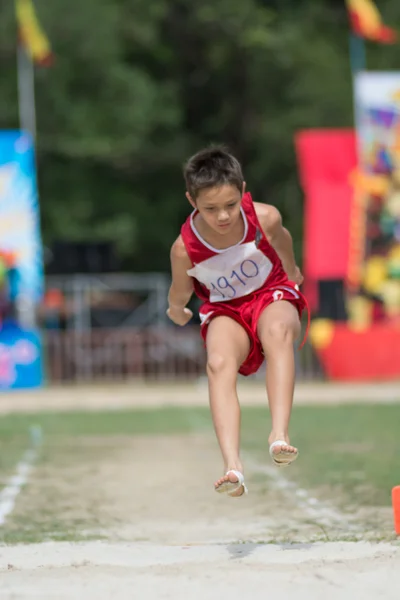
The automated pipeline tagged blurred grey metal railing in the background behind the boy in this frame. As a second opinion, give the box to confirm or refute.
[42,273,323,382]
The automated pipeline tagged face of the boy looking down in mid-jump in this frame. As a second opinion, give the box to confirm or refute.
[186,184,245,235]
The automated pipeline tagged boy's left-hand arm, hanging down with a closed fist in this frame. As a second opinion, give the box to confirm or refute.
[167,236,193,325]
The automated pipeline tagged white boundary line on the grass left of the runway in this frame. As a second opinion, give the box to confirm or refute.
[0,426,42,527]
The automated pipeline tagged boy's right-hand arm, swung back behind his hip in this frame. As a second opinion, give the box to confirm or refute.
[254,202,303,285]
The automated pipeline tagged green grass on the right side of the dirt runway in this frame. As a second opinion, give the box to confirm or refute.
[243,404,400,506]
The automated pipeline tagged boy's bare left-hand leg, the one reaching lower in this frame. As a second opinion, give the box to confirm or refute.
[206,317,250,496]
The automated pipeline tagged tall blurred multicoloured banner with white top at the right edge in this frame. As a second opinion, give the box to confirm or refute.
[352,73,400,310]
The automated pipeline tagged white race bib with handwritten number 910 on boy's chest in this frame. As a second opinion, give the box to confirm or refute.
[187,242,272,302]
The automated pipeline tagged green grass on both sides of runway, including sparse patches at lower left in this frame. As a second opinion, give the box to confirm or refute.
[0,403,400,543]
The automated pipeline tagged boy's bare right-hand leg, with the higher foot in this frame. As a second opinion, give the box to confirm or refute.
[257,301,301,454]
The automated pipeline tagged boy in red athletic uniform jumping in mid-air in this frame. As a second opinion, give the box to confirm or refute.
[167,147,306,496]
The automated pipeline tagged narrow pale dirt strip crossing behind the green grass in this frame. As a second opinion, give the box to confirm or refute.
[0,378,400,414]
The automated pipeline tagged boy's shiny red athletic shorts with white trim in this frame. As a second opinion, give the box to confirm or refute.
[199,282,307,375]
